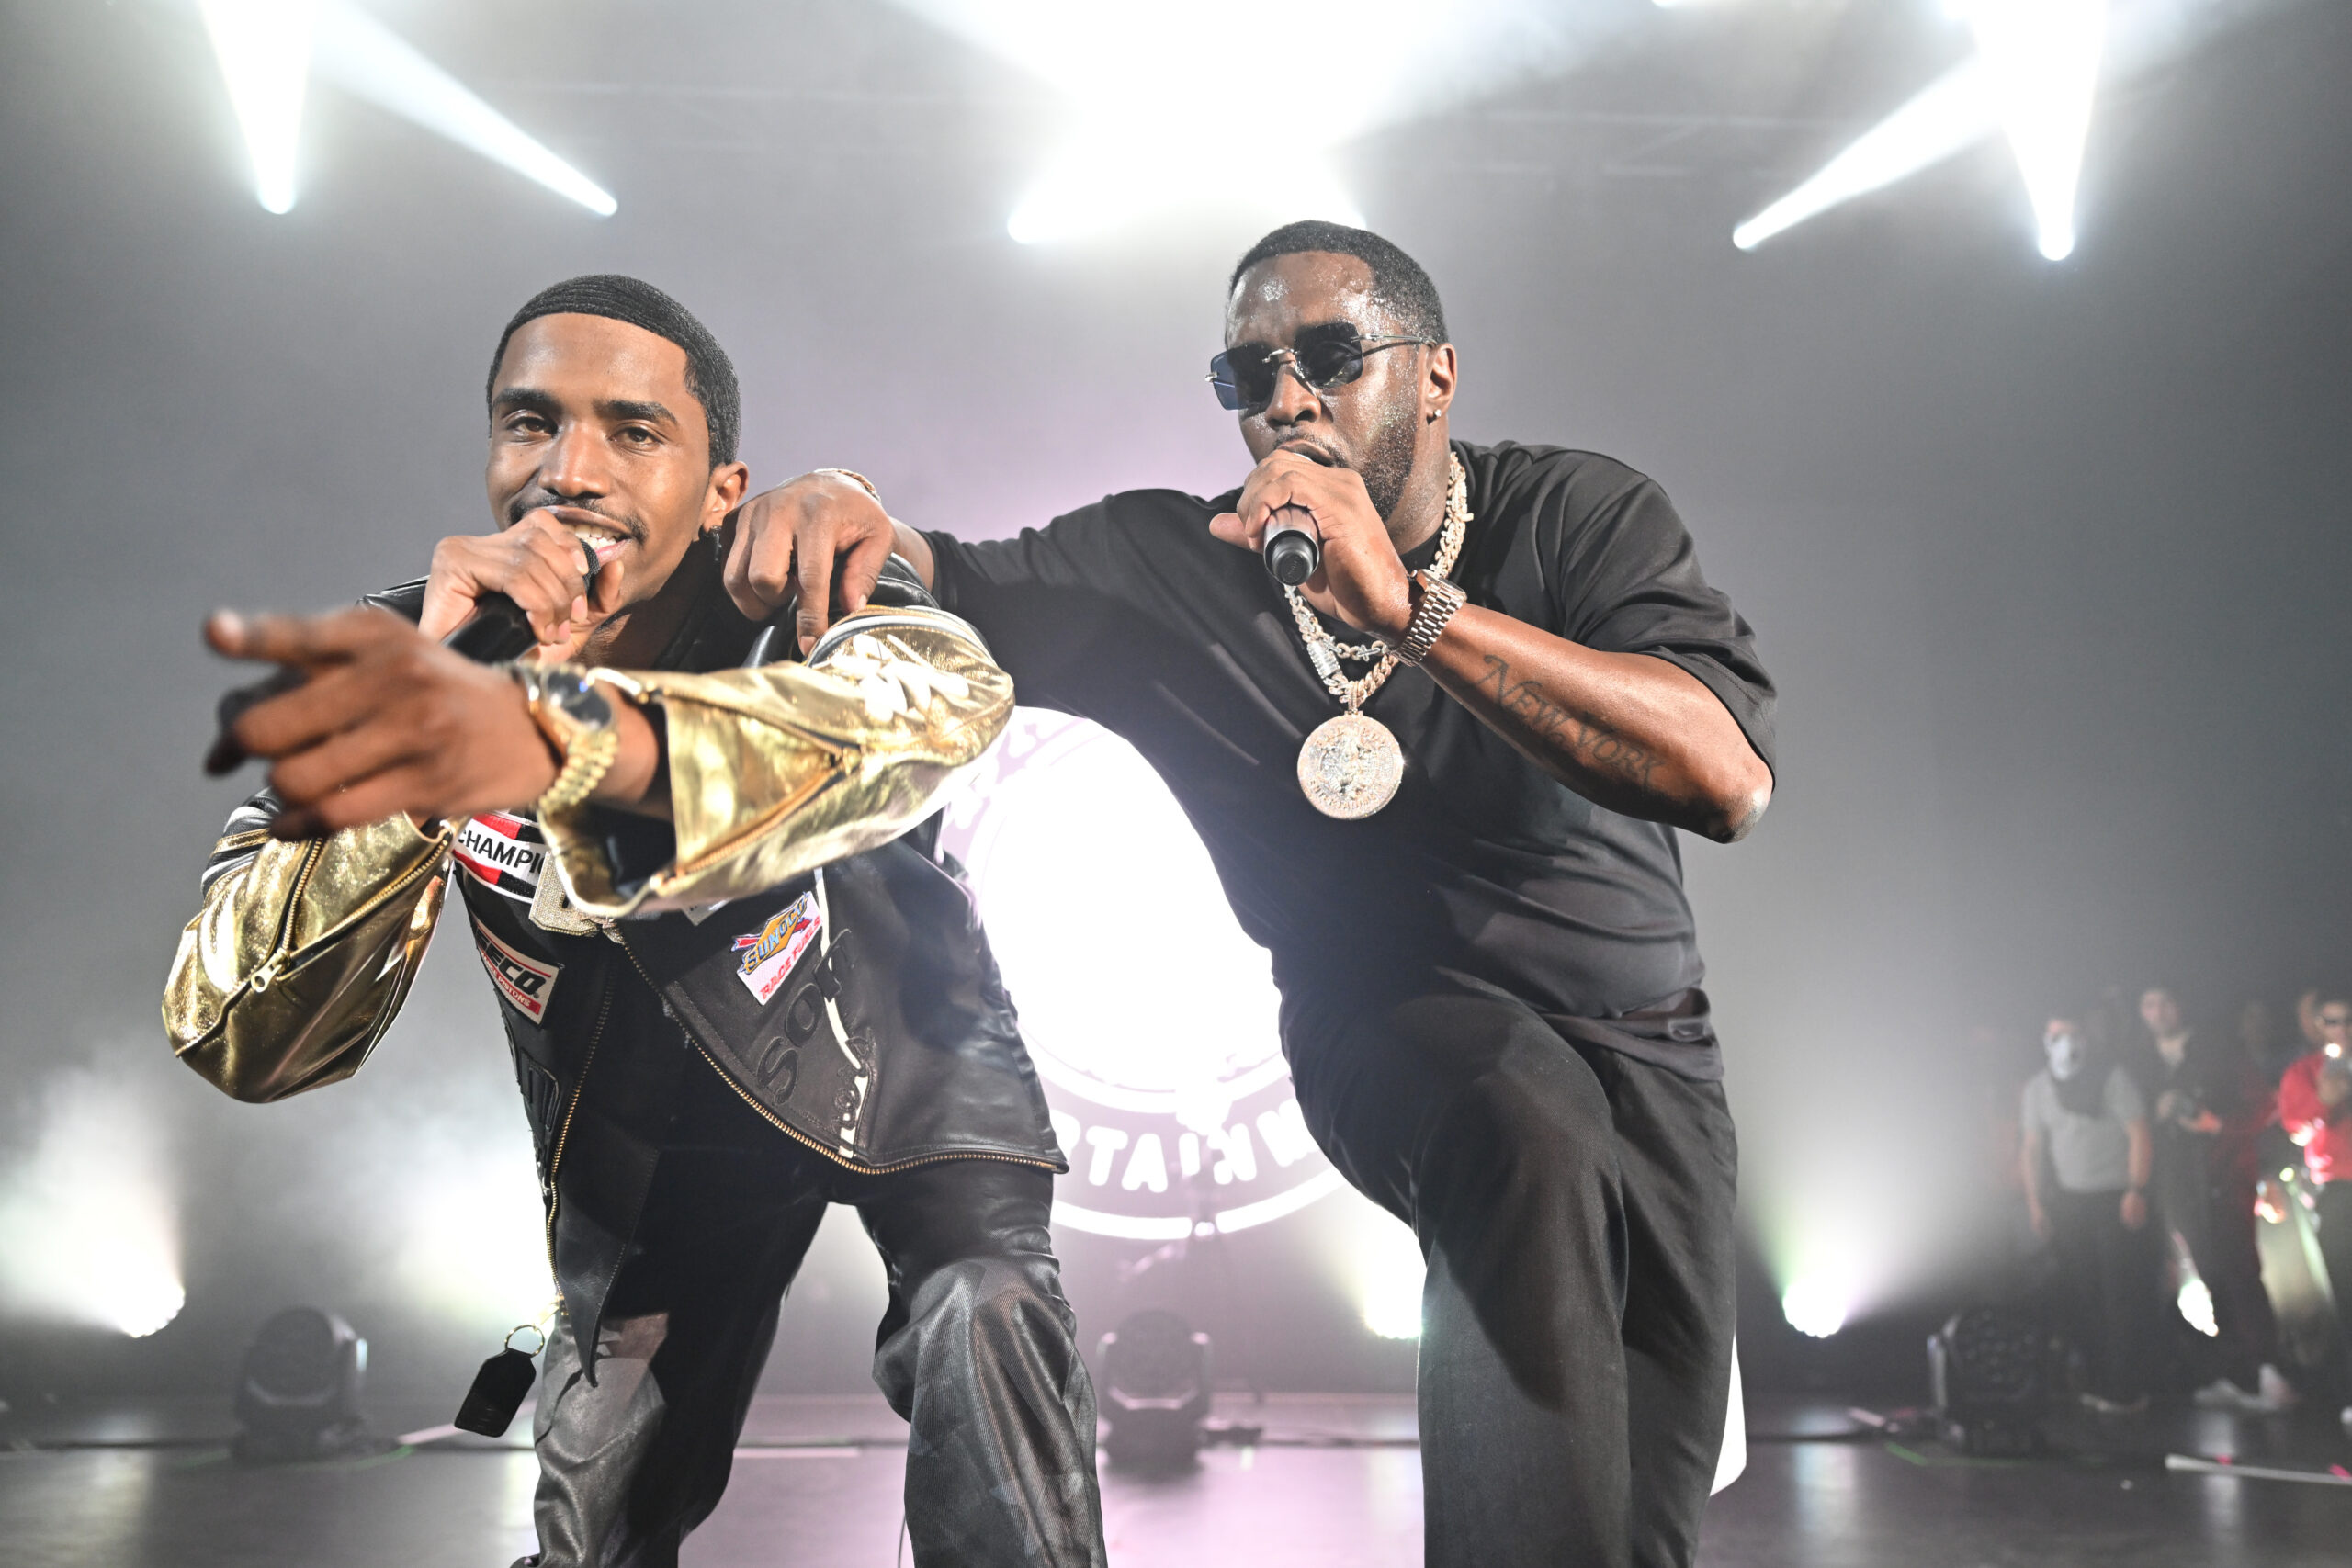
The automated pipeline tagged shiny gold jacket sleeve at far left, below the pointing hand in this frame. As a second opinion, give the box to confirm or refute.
[163,797,452,1102]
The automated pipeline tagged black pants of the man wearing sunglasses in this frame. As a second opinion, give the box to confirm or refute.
[1284,980,1738,1568]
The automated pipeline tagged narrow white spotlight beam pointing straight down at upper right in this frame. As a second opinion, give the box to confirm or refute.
[1969,0,2108,261]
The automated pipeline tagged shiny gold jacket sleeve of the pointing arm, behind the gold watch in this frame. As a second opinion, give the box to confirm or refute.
[541,606,1013,919]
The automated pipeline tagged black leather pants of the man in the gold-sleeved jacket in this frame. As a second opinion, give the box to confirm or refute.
[517,1075,1103,1568]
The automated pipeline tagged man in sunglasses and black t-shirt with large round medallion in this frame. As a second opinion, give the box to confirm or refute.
[727,223,1773,1568]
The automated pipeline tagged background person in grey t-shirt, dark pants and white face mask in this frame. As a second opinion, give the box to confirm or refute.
[2018,1018,2157,1416]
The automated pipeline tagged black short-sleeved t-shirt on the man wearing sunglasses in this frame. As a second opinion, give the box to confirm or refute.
[929,442,1773,1077]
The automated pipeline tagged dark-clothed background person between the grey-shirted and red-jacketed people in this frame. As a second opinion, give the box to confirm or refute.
[2141,985,2296,1413]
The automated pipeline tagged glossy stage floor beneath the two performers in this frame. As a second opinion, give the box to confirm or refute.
[0,1396,2352,1568]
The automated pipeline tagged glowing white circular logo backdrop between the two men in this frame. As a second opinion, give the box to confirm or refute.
[941,707,1340,1241]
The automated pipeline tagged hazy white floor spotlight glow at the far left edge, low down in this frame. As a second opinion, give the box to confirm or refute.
[0,1072,188,1340]
